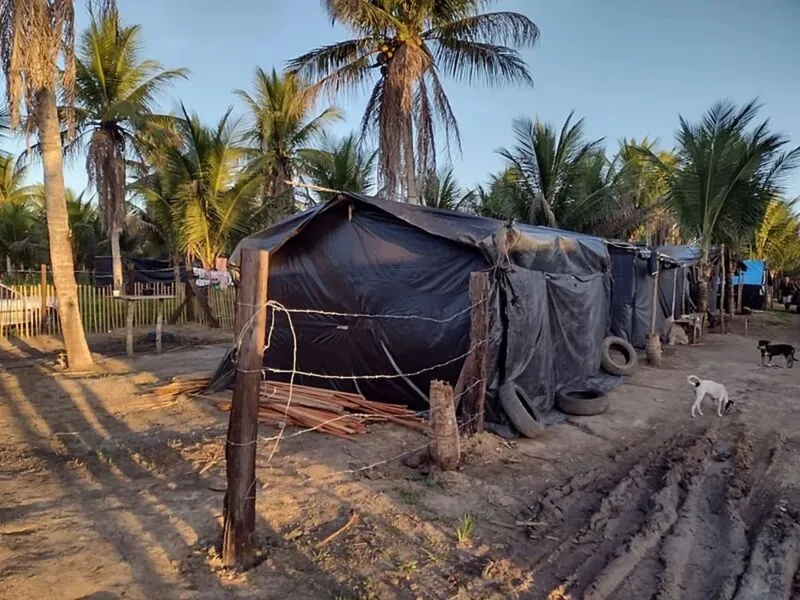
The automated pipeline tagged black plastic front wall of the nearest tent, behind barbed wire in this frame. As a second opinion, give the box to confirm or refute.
[255,207,487,410]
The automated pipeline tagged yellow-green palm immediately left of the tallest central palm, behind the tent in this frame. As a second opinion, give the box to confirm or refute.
[235,68,341,222]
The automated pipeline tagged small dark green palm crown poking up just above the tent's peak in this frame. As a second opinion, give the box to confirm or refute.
[299,134,375,200]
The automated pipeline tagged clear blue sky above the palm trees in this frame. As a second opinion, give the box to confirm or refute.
[10,0,800,197]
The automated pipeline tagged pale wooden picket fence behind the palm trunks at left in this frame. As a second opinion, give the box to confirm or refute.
[0,282,236,339]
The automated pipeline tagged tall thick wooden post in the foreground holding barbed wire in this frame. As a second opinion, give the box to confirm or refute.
[222,249,269,570]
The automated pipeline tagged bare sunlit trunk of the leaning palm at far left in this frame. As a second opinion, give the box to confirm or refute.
[36,89,93,371]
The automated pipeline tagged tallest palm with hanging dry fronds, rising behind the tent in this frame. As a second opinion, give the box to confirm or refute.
[289,0,539,203]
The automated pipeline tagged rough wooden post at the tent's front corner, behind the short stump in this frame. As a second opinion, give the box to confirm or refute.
[454,271,490,433]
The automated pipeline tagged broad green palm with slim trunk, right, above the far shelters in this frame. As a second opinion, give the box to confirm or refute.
[653,101,800,322]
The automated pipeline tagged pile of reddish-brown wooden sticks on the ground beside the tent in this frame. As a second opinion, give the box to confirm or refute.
[150,376,429,438]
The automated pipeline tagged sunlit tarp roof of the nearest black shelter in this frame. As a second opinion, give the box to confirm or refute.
[230,192,620,276]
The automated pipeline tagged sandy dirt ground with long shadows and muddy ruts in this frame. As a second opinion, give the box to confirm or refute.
[0,314,800,600]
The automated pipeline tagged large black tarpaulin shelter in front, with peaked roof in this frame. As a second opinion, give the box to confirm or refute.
[212,193,611,423]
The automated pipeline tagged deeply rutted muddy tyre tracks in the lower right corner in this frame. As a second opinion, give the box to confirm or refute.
[529,427,800,600]
